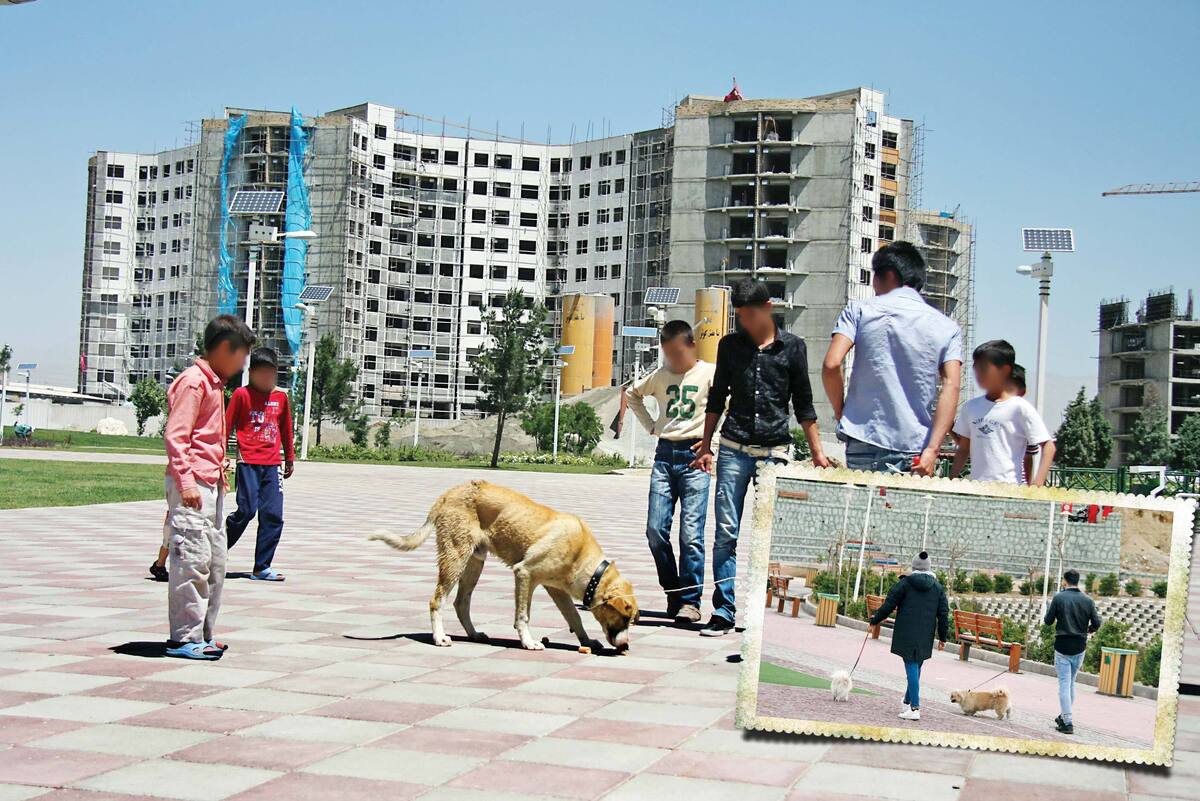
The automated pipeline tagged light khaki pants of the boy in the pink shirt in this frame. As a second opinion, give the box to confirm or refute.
[167,476,226,643]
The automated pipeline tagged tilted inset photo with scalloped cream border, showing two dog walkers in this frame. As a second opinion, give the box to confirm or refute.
[737,465,1195,765]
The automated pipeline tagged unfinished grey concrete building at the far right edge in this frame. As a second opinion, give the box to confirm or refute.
[1098,289,1200,466]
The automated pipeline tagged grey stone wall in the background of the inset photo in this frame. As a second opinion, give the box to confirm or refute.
[770,477,1121,577]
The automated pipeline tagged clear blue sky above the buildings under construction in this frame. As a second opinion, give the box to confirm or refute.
[0,0,1200,421]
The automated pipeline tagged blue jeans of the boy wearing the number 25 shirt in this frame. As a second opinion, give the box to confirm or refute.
[646,439,710,607]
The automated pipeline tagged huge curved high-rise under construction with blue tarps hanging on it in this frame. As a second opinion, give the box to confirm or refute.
[79,89,972,418]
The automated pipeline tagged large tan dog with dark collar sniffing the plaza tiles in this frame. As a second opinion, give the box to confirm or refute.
[371,480,637,651]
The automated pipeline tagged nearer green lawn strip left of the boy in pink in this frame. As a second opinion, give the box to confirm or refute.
[0,459,163,508]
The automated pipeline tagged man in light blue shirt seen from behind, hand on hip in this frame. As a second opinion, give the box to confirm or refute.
[821,242,962,476]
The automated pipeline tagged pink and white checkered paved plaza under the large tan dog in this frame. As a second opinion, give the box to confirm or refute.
[0,454,1200,801]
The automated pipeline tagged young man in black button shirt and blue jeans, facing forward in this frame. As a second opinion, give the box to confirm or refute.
[692,278,829,637]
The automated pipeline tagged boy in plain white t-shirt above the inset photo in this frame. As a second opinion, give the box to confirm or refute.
[950,339,1055,487]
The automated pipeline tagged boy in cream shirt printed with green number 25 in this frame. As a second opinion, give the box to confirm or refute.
[628,320,715,624]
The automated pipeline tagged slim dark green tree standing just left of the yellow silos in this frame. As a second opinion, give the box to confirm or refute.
[470,289,553,468]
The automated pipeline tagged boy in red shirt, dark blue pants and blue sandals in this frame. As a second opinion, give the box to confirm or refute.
[226,348,295,582]
